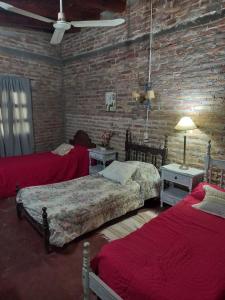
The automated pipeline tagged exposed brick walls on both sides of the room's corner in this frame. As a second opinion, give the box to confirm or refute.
[0,0,225,165]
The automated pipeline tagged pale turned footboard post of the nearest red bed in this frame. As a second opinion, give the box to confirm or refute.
[82,242,90,300]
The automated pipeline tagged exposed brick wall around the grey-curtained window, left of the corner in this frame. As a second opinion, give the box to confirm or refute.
[0,27,63,151]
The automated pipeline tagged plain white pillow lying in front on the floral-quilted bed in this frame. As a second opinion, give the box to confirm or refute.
[99,160,137,185]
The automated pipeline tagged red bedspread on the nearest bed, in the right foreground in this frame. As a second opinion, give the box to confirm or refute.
[92,183,225,300]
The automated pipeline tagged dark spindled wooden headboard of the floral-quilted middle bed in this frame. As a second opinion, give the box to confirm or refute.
[125,130,168,169]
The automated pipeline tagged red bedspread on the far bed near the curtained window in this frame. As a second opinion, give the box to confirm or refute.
[0,145,89,199]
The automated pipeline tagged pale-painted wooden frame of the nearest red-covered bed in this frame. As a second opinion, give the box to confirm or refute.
[82,141,225,300]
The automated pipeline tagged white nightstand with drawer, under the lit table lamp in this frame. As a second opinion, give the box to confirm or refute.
[160,164,204,207]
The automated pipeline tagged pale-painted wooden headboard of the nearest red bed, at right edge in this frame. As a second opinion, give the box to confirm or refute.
[205,140,225,187]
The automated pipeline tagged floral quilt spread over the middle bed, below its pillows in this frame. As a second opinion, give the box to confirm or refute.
[17,174,144,247]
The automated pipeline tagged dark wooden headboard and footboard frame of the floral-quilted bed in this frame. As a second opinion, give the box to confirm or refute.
[16,130,167,253]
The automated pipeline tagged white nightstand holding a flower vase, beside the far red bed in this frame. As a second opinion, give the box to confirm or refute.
[88,148,117,174]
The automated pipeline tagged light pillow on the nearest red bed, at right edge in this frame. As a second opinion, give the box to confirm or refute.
[193,185,225,218]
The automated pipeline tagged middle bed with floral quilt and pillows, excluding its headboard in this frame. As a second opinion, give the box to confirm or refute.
[16,131,168,251]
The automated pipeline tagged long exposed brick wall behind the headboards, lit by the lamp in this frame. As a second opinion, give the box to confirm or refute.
[62,0,225,166]
